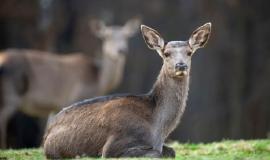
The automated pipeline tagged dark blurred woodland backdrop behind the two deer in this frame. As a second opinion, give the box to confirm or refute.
[0,0,270,148]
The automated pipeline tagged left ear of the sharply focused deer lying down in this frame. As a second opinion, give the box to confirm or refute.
[141,25,164,50]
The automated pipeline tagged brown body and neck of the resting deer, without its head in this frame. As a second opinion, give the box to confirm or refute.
[44,67,188,158]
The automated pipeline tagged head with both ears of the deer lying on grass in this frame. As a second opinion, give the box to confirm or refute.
[141,23,211,78]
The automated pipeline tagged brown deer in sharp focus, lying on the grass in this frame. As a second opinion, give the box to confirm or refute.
[43,23,211,158]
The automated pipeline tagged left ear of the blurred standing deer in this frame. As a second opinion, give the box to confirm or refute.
[89,20,106,38]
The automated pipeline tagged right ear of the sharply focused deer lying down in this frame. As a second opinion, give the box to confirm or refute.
[188,23,211,51]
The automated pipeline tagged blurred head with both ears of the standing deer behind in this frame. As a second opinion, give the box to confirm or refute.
[90,18,140,58]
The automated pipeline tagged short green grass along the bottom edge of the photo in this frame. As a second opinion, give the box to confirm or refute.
[0,139,270,160]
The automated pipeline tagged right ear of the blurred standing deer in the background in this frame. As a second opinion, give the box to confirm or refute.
[123,18,141,37]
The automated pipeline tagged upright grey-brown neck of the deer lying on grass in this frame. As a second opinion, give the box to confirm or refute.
[151,64,189,141]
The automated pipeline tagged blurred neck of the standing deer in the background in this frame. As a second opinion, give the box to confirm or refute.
[98,55,126,95]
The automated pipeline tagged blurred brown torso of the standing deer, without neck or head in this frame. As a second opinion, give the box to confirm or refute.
[0,49,98,117]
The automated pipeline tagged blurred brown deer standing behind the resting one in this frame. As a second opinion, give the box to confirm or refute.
[0,18,140,148]
